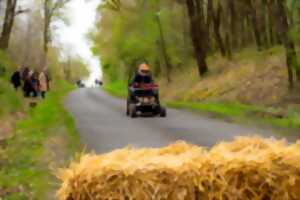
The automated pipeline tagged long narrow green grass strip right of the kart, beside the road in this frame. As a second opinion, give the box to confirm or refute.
[167,102,300,130]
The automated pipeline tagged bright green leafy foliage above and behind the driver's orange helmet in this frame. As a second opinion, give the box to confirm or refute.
[91,1,192,81]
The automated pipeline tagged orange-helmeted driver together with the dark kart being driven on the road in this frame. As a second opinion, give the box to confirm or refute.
[127,63,166,117]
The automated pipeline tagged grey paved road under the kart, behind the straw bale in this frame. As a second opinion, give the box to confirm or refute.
[66,89,292,153]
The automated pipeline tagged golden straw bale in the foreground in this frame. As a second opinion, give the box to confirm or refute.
[58,137,300,200]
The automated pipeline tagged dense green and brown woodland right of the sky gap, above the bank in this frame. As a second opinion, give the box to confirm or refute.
[94,0,300,89]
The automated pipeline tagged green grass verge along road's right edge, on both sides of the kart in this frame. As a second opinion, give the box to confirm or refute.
[104,81,300,130]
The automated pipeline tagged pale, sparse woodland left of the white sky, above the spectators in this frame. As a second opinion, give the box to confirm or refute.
[0,0,88,82]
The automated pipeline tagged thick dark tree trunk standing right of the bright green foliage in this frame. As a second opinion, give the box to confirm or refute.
[186,0,208,76]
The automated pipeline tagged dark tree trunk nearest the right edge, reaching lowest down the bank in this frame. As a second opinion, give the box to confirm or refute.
[273,0,300,89]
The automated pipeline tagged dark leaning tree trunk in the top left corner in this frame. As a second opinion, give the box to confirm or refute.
[0,0,17,50]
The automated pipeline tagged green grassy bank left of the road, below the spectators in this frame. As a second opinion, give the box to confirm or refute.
[0,81,79,200]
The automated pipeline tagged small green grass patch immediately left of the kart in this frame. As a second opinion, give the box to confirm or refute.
[103,81,127,98]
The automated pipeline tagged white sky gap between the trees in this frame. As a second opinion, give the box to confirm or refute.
[57,0,102,84]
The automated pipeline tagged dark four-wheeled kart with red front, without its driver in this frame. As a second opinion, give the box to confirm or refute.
[126,83,167,118]
